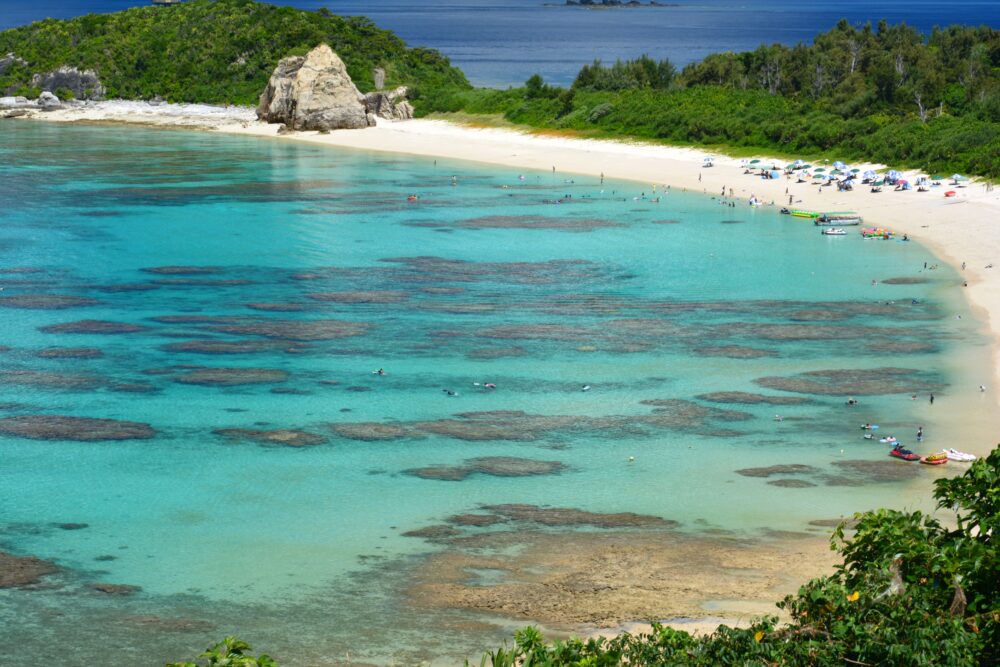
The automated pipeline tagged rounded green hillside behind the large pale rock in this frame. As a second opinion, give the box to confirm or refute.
[0,0,469,104]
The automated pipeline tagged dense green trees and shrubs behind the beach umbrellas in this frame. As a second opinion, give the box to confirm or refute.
[418,21,1000,177]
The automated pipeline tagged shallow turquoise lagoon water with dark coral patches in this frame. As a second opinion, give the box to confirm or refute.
[0,123,987,665]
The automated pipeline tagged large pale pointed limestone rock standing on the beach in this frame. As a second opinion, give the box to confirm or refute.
[257,44,374,130]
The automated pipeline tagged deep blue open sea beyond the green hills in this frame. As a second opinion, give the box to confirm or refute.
[0,0,1000,87]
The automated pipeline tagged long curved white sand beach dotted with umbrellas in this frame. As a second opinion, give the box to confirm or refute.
[15,101,1000,412]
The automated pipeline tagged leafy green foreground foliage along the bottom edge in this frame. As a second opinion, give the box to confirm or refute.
[170,448,1000,667]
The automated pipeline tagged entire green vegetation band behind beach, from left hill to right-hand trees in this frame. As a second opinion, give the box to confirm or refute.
[0,0,1000,178]
